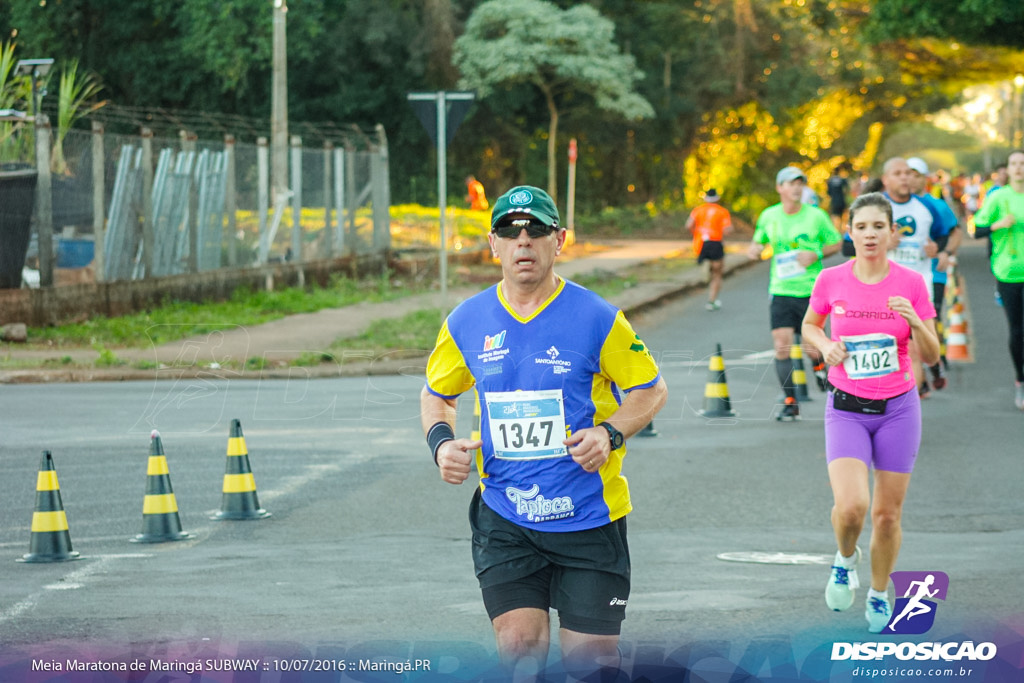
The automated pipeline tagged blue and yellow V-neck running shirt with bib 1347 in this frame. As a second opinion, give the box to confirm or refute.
[427,280,659,531]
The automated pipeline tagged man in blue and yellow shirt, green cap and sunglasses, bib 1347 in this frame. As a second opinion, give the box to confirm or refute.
[421,186,668,673]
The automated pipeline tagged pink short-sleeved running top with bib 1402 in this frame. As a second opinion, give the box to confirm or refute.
[810,260,935,399]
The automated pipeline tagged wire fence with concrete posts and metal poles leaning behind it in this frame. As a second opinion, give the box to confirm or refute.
[29,124,391,284]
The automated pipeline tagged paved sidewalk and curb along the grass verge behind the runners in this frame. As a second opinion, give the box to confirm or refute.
[0,240,750,384]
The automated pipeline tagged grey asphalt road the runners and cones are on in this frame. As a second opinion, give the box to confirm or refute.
[0,239,1024,681]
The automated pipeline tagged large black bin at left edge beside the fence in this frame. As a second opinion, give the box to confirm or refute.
[0,164,37,289]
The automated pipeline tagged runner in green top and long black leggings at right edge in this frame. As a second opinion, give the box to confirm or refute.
[974,150,1024,411]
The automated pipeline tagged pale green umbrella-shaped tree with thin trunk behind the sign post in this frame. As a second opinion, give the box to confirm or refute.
[453,0,654,198]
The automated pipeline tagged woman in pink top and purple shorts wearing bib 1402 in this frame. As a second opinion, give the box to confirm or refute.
[802,193,939,633]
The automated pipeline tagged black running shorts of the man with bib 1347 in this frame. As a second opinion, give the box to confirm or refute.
[469,488,630,636]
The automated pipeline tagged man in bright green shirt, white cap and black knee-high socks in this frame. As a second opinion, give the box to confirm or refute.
[748,166,842,422]
